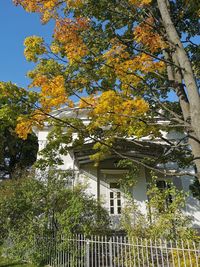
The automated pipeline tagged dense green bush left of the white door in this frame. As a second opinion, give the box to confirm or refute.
[0,171,109,262]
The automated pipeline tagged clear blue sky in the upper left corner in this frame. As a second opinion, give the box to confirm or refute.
[0,0,53,87]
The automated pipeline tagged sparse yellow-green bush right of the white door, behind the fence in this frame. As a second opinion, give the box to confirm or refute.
[121,177,197,241]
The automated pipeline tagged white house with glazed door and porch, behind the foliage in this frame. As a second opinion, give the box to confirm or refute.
[34,105,200,230]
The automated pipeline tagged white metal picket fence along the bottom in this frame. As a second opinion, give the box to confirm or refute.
[39,235,200,267]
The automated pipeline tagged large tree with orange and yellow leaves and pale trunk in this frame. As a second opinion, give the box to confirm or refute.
[14,0,200,182]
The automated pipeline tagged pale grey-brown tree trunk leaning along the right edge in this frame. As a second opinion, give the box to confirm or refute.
[157,0,200,181]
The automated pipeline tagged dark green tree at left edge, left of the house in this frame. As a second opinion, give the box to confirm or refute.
[0,82,38,179]
